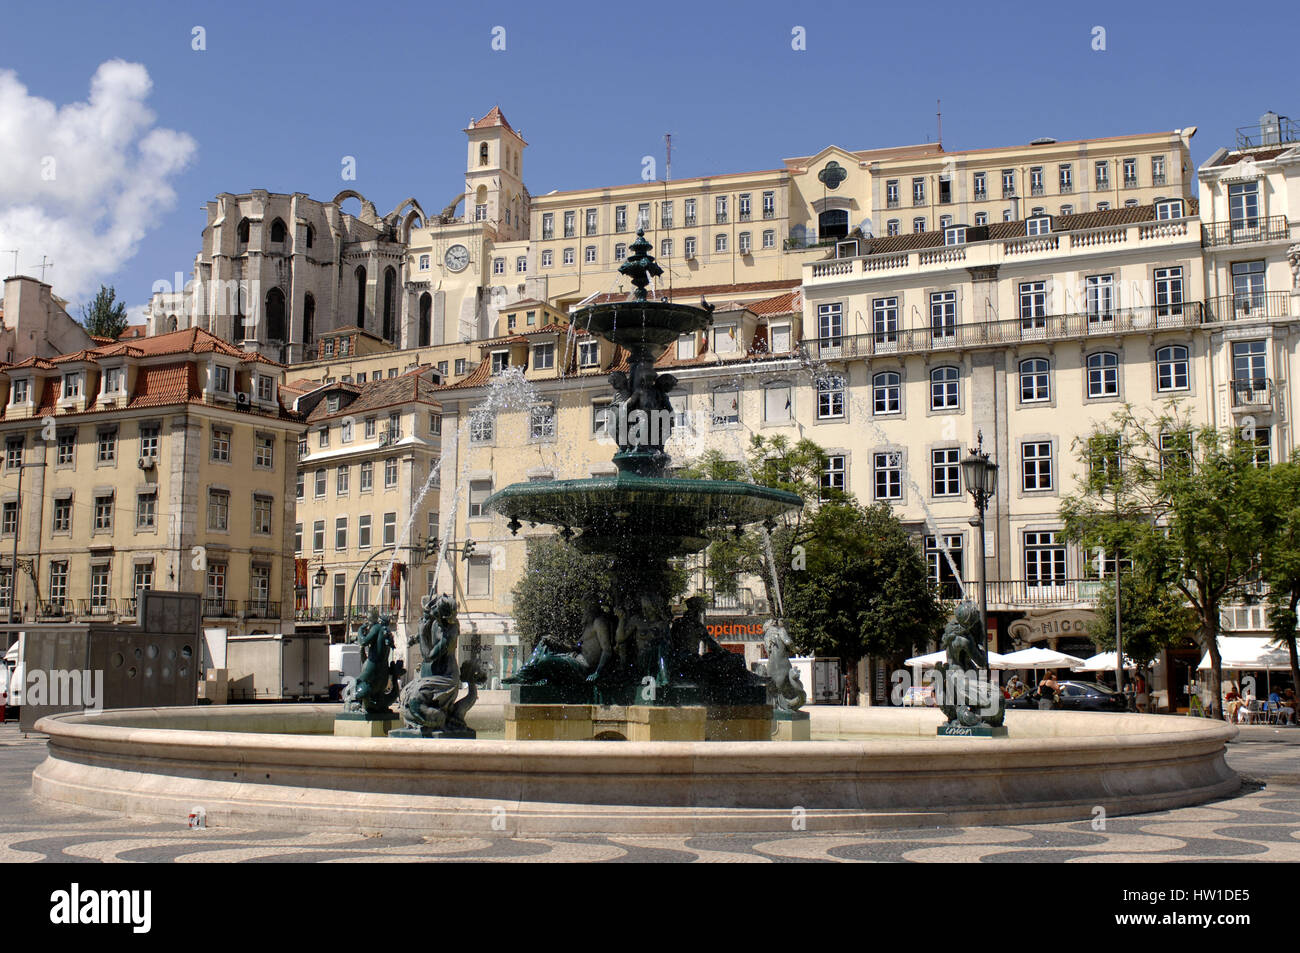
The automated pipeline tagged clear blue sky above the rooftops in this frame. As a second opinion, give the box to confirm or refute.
[0,0,1300,312]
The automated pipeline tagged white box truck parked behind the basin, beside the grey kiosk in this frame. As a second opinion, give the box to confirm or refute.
[226,633,330,702]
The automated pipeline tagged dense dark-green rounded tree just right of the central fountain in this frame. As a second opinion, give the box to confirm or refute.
[785,501,946,666]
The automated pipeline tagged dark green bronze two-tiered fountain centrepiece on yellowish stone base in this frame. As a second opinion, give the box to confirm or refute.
[485,231,802,741]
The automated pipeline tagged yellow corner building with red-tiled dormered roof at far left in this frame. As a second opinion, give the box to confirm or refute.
[0,329,303,634]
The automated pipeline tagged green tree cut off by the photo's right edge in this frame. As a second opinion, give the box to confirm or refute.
[1257,459,1300,685]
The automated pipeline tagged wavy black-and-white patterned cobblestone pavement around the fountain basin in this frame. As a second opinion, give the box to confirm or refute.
[0,724,1300,863]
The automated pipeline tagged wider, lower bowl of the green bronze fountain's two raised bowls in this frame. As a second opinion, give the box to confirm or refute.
[486,472,803,547]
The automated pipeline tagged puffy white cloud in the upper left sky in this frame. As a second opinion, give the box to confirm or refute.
[0,60,196,300]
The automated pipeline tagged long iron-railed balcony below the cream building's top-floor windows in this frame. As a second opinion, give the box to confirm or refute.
[801,304,1201,360]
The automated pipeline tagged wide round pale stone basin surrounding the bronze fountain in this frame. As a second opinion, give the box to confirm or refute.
[25,705,1240,836]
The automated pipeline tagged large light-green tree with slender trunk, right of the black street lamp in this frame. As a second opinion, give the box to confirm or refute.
[1061,402,1266,716]
